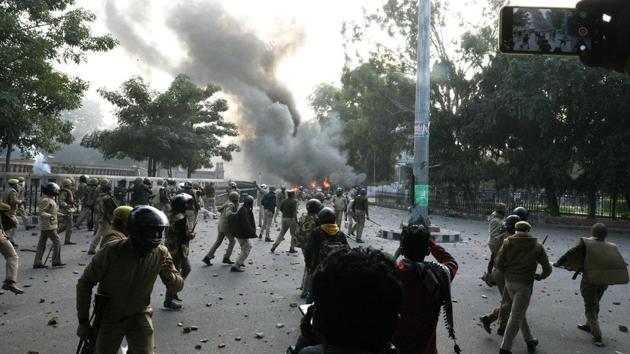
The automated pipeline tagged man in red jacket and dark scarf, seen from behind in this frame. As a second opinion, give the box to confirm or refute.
[393,225,459,354]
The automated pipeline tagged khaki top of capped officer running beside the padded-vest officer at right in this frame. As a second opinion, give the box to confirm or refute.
[494,231,551,285]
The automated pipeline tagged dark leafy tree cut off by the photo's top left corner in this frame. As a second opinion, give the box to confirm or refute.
[0,0,116,167]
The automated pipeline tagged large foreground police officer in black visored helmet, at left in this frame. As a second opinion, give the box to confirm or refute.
[77,206,184,354]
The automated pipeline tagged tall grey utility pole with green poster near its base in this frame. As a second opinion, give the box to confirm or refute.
[411,0,431,220]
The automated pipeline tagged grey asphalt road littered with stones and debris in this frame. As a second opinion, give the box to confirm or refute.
[0,208,630,354]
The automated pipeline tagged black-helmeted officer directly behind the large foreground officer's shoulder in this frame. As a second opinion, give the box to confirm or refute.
[164,193,195,310]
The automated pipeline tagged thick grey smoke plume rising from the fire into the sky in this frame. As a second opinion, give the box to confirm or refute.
[106,1,365,185]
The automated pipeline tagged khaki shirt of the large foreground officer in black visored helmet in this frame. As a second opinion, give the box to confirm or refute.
[77,239,184,323]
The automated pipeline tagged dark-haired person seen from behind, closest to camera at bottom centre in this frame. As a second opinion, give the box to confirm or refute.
[289,246,402,354]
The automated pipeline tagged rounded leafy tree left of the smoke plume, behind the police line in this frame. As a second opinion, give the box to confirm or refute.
[81,74,239,176]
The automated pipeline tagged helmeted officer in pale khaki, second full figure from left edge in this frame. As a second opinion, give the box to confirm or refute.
[33,182,65,269]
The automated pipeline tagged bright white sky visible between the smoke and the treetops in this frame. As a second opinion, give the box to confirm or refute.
[62,0,575,129]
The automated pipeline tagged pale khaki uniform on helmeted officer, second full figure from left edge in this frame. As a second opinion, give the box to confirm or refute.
[33,195,61,266]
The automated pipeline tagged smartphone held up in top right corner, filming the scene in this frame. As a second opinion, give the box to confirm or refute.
[499,6,591,55]
